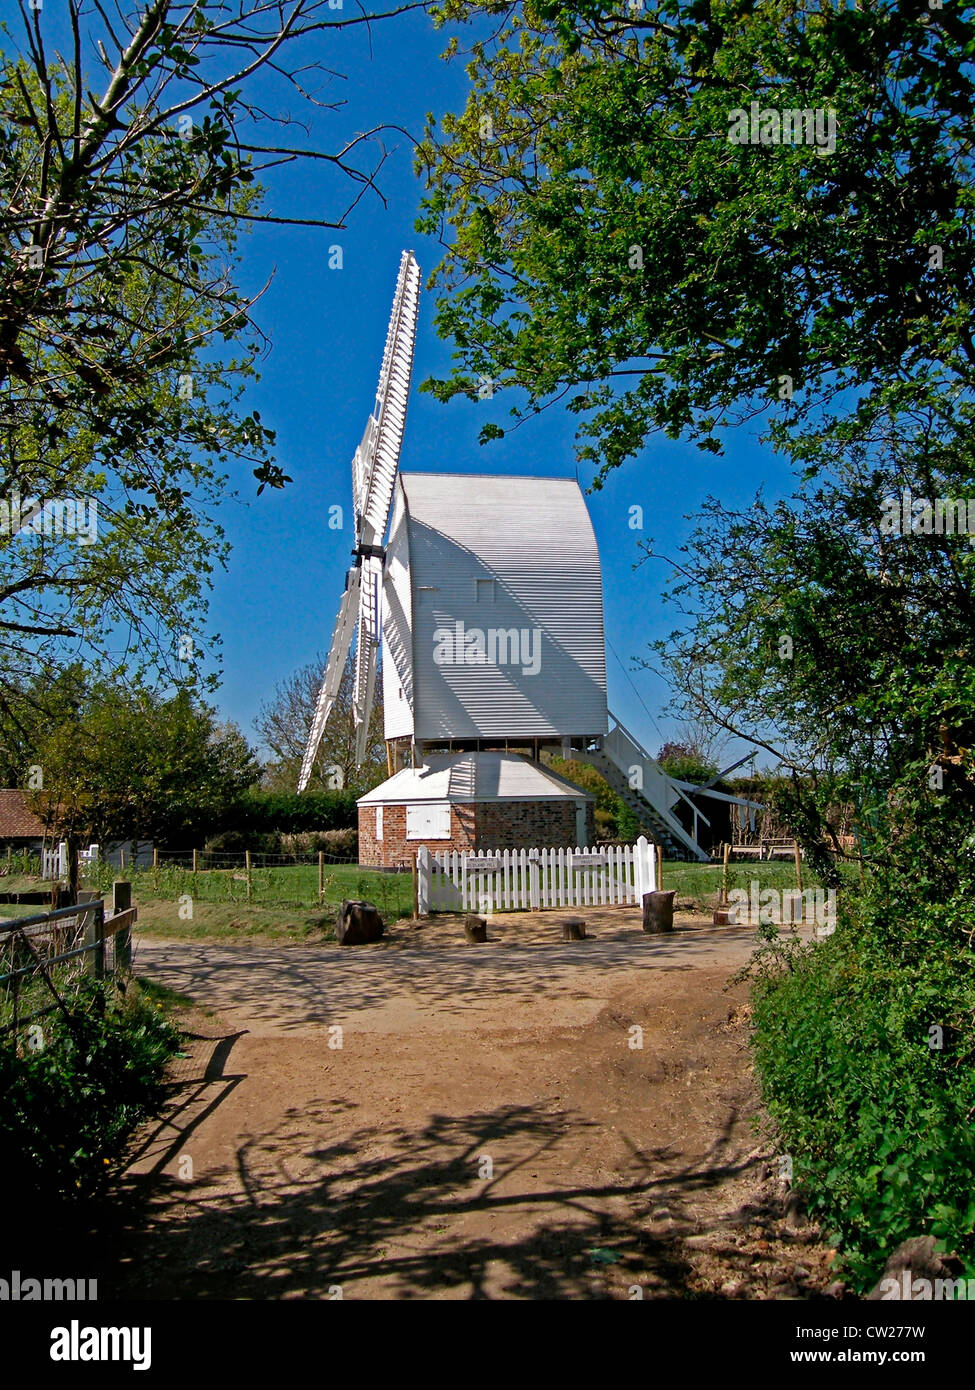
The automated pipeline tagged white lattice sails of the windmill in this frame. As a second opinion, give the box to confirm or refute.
[298,252,420,791]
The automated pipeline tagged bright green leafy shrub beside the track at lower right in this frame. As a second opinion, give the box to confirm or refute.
[752,891,975,1289]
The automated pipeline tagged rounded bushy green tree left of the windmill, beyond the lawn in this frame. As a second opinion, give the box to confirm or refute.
[26,685,260,848]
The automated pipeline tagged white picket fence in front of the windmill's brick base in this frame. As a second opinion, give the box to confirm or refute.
[416,835,656,913]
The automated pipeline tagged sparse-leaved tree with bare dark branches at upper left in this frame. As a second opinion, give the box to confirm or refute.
[0,0,417,711]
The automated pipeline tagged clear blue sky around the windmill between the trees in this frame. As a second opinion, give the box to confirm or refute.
[139,14,789,752]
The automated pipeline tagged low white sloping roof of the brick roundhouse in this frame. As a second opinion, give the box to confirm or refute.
[357,752,593,806]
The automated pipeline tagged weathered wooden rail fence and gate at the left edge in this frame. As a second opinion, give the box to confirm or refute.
[0,880,138,1047]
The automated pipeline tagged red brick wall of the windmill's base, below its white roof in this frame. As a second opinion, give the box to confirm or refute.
[359,801,595,869]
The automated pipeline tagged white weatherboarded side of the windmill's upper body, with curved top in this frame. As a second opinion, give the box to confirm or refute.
[387,473,606,739]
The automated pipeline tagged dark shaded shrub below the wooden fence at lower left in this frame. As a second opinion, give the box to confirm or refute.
[0,984,179,1202]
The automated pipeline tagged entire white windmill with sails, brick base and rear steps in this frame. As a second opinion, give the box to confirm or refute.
[299,252,708,866]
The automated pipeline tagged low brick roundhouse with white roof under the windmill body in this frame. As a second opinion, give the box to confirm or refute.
[357,752,595,869]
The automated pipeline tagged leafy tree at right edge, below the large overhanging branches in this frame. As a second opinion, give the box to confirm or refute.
[645,405,975,895]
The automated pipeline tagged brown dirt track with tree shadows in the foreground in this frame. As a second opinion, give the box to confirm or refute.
[102,909,832,1298]
